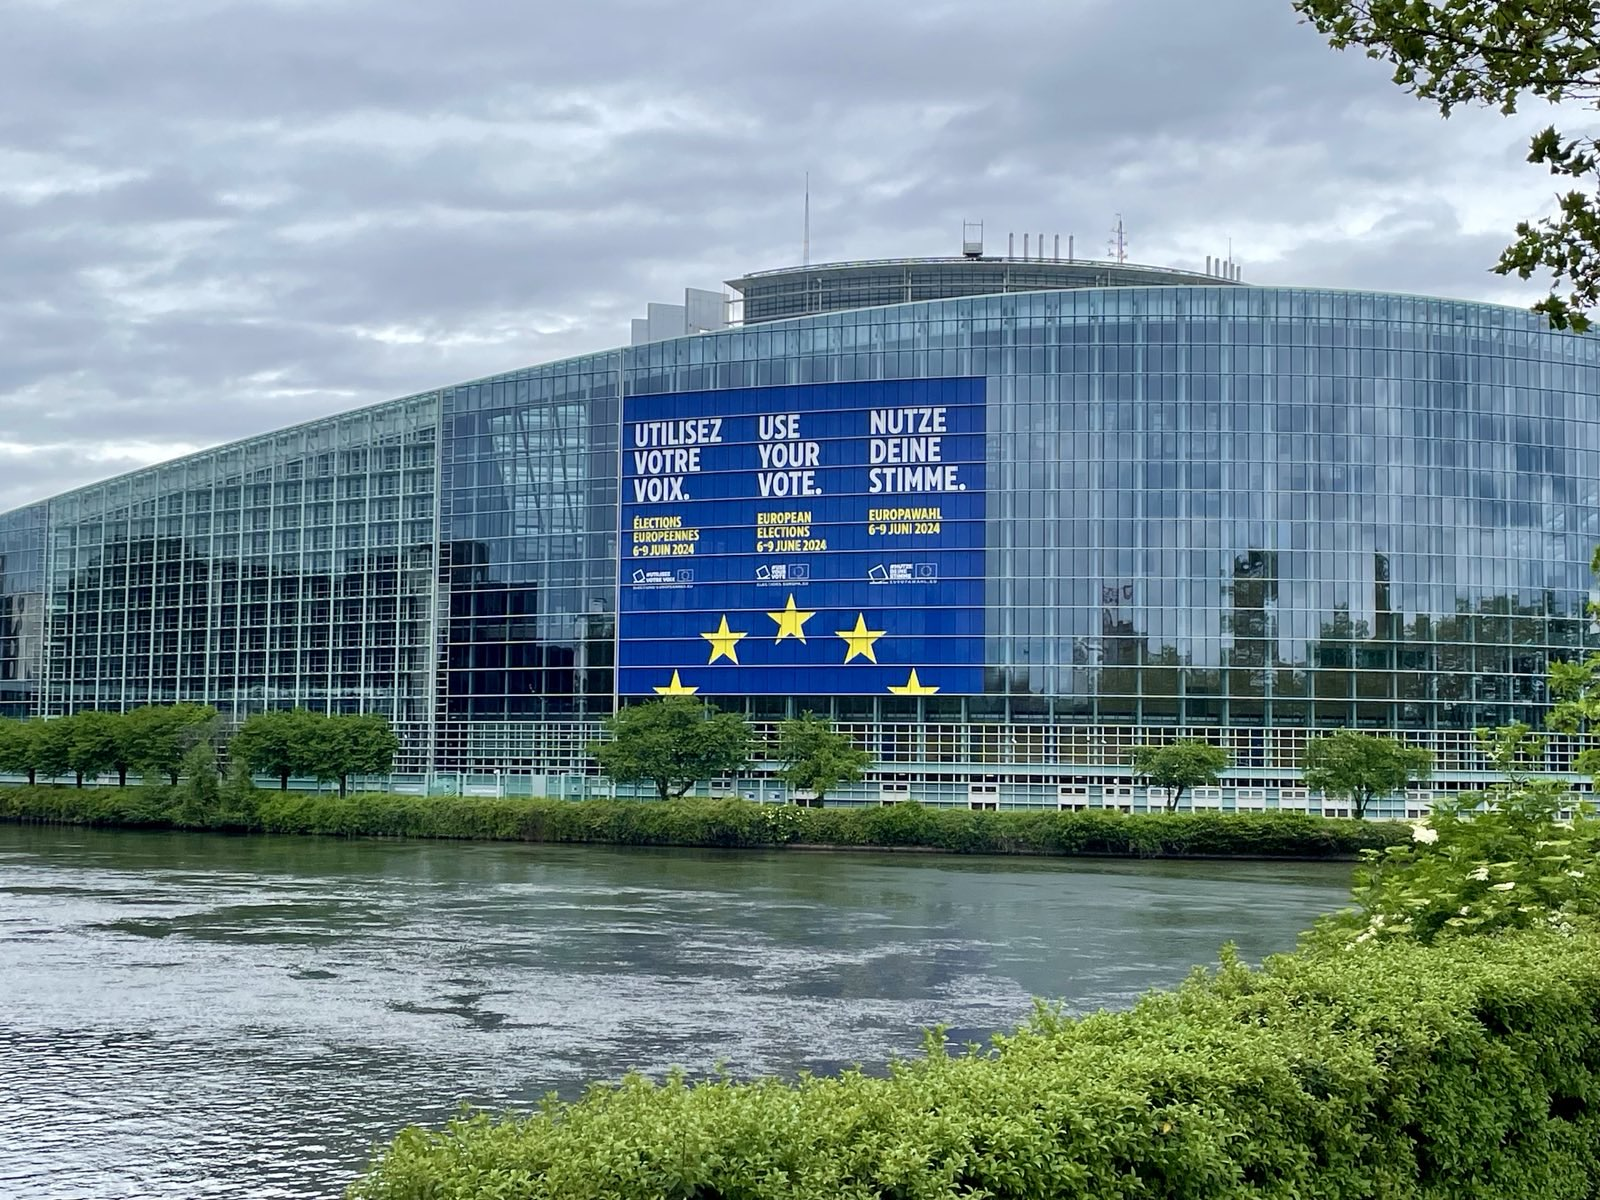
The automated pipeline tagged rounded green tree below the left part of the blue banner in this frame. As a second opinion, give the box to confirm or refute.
[589,696,750,800]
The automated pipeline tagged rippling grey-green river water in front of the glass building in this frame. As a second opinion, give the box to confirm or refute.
[0,826,1349,1200]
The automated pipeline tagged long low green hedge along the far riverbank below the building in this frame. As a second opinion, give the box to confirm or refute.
[0,787,1410,858]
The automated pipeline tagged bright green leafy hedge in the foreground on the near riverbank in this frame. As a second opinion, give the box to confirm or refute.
[349,933,1600,1200]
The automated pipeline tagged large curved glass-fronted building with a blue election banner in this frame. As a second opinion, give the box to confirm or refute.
[0,259,1600,808]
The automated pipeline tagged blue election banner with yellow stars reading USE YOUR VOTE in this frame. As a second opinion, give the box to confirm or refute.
[618,379,986,696]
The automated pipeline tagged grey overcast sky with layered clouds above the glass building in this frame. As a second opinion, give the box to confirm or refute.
[0,0,1554,510]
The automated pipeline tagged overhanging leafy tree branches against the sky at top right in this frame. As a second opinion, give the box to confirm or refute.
[1294,0,1600,331]
